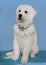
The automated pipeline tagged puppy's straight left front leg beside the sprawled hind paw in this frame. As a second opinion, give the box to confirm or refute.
[12,37,20,60]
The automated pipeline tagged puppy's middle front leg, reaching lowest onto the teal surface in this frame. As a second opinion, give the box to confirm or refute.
[21,45,30,64]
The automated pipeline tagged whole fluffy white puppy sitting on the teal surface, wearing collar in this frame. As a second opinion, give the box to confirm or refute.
[7,5,39,64]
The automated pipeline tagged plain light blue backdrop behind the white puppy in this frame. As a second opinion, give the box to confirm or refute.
[0,0,46,51]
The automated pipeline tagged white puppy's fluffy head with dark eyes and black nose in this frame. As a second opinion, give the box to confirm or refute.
[16,5,36,26]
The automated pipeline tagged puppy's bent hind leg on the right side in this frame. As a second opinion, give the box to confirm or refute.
[30,35,39,58]
